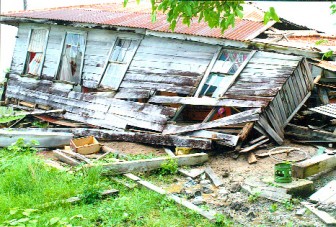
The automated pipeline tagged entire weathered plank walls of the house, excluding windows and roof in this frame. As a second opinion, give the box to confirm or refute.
[6,24,312,146]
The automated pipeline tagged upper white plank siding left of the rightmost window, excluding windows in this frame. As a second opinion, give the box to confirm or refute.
[11,24,217,95]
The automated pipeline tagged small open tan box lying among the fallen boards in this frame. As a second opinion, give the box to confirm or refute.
[70,136,101,154]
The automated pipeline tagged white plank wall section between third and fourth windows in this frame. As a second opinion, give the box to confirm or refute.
[121,36,216,95]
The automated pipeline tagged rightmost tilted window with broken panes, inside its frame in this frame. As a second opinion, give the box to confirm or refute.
[200,50,249,98]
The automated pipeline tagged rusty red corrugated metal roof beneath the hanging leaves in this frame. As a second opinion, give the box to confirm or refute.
[3,3,265,41]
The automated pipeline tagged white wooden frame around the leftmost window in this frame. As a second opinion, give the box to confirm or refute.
[21,26,50,79]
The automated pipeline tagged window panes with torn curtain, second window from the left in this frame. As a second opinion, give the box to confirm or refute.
[58,32,85,84]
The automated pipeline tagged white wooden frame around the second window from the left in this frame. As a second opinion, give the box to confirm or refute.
[54,30,88,86]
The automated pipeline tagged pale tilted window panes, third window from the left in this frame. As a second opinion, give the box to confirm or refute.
[100,38,139,90]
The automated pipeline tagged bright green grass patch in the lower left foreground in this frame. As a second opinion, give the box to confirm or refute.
[0,145,226,226]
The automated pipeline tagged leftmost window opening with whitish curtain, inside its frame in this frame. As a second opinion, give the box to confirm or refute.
[25,29,48,76]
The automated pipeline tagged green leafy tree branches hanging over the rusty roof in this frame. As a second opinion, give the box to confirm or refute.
[124,0,279,32]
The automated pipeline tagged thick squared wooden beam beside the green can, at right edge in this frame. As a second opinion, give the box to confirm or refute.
[292,154,336,179]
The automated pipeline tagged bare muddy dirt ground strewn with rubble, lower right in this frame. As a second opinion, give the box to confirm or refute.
[98,140,336,226]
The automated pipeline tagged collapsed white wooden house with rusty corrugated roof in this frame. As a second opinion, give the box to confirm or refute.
[1,3,320,149]
